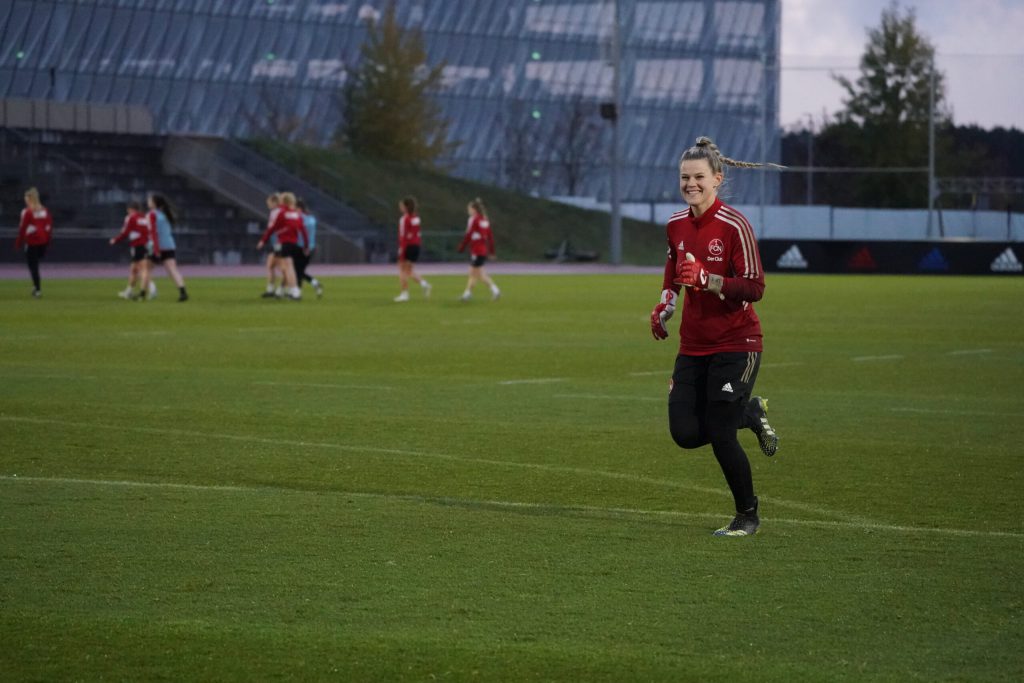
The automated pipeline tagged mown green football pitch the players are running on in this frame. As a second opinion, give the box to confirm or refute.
[0,275,1024,681]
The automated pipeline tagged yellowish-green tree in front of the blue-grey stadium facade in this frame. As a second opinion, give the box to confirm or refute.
[341,2,458,165]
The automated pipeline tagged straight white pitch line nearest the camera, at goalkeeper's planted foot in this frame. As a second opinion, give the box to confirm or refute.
[0,475,1024,539]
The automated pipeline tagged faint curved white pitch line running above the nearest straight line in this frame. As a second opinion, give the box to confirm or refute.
[0,416,881,524]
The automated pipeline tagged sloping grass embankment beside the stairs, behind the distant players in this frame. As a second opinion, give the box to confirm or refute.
[252,140,663,265]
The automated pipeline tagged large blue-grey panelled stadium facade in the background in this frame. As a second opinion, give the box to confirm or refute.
[0,0,781,204]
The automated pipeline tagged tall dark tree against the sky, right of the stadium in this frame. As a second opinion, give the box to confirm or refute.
[819,3,948,207]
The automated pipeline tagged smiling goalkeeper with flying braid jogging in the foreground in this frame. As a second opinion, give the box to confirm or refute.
[650,137,778,536]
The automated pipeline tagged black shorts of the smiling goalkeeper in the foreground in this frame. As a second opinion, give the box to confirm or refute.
[669,351,761,412]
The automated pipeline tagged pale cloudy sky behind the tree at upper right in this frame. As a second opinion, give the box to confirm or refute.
[779,0,1024,130]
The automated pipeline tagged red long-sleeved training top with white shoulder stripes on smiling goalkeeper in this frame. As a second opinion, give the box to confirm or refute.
[663,199,765,355]
